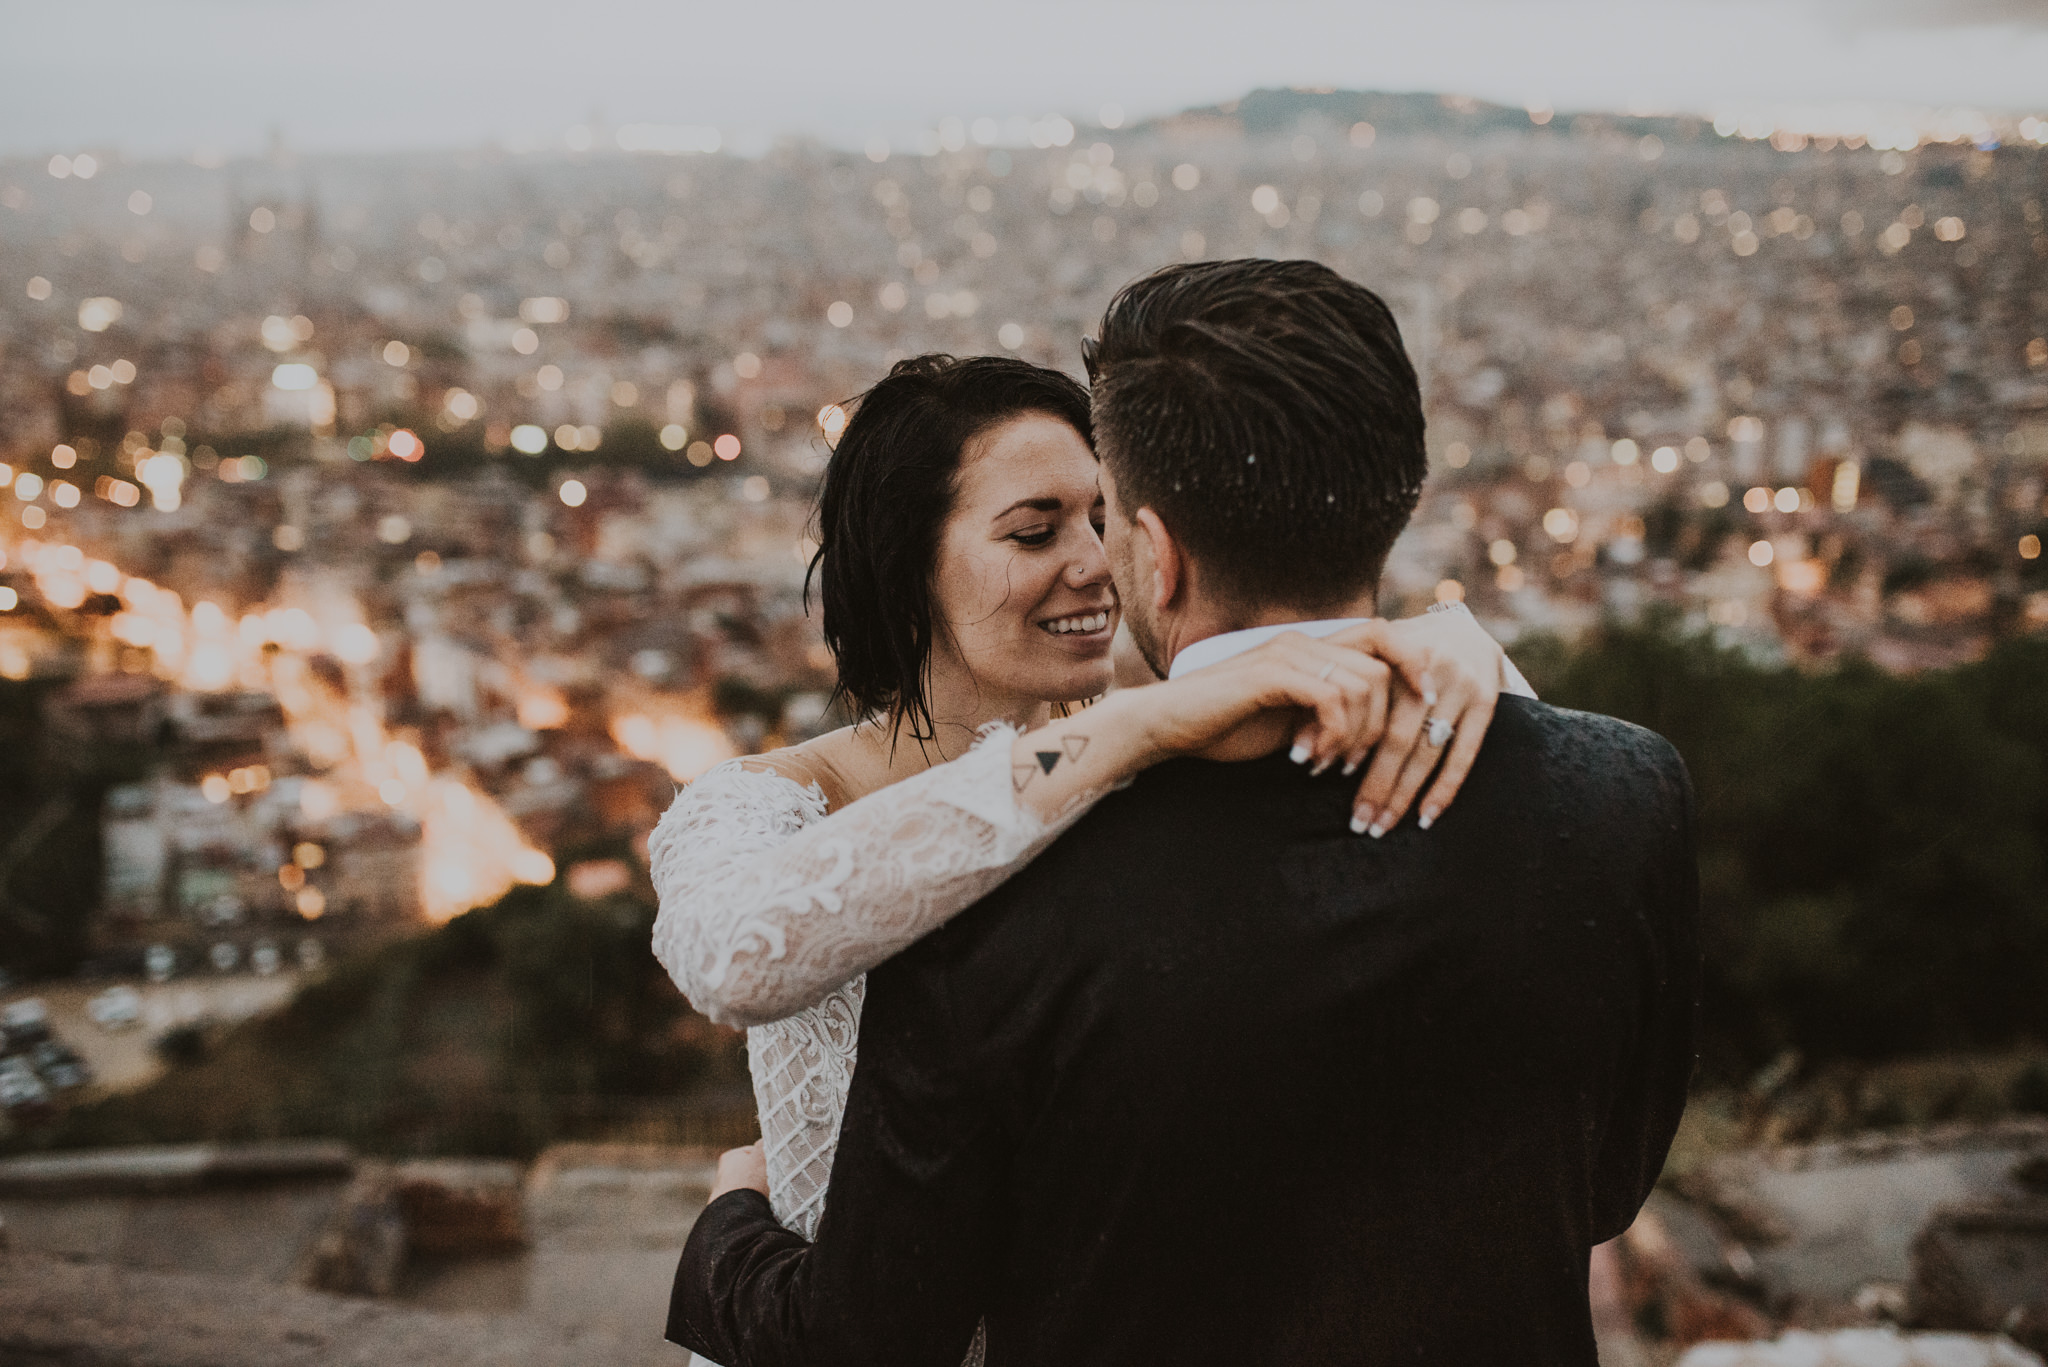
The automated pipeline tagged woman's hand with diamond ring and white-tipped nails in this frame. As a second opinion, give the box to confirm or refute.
[1329,611,1509,836]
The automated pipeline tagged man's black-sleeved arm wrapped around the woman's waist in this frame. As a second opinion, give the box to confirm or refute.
[668,949,1008,1367]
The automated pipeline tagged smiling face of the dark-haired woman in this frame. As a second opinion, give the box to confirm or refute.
[932,414,1116,703]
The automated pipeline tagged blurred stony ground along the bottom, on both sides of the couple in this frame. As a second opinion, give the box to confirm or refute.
[0,1119,2048,1367]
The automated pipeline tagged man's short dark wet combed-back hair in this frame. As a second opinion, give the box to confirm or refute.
[1083,260,1427,611]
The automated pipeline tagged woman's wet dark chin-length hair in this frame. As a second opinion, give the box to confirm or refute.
[805,355,1092,740]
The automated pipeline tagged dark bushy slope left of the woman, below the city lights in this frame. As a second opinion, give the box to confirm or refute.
[22,883,752,1156]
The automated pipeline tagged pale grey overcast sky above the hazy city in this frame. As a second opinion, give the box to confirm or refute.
[0,0,2048,156]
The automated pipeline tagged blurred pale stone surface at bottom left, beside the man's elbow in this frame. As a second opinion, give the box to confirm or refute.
[0,1146,715,1367]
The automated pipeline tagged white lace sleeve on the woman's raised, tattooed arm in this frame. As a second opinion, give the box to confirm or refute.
[647,728,1100,1025]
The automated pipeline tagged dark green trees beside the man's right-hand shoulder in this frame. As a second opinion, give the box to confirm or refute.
[1516,619,2048,1076]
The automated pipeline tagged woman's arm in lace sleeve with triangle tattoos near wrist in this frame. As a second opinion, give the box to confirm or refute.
[649,610,1531,1025]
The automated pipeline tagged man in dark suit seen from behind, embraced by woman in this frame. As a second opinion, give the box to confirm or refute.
[668,260,1698,1367]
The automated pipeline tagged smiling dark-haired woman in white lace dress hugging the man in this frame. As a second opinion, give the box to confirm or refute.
[649,357,1528,1344]
